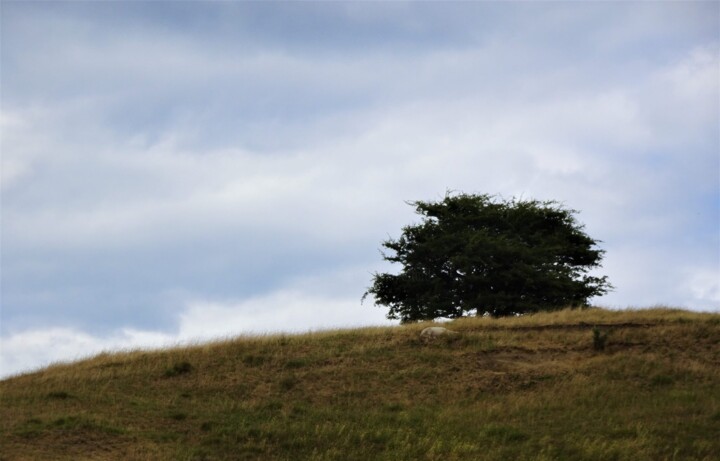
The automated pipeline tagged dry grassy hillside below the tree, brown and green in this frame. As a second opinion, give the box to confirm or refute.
[0,309,720,461]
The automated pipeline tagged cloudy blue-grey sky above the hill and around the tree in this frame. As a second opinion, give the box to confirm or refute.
[0,0,720,376]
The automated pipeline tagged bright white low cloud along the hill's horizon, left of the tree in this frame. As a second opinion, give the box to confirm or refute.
[0,286,397,378]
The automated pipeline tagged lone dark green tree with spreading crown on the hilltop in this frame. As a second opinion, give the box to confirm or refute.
[363,193,612,322]
